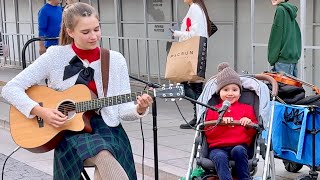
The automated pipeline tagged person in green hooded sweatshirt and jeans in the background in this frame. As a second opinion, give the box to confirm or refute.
[268,0,301,77]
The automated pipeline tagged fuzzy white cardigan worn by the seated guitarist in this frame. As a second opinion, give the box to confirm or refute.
[2,45,147,127]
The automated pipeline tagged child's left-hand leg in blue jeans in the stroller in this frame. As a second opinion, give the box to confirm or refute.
[209,149,232,180]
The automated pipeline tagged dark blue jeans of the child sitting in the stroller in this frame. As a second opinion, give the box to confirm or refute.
[209,145,251,180]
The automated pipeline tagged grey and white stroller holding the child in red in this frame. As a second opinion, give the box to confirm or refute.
[186,74,278,180]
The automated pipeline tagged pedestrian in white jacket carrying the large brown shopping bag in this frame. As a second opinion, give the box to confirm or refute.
[170,0,211,129]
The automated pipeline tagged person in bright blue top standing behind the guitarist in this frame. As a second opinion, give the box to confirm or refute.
[38,0,62,55]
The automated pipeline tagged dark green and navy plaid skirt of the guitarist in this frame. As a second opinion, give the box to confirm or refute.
[53,115,137,180]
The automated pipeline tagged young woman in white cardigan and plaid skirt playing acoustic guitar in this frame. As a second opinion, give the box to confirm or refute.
[2,2,152,180]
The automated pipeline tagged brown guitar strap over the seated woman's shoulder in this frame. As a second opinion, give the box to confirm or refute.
[101,48,110,97]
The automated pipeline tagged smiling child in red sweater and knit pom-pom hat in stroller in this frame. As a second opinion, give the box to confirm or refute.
[205,63,258,180]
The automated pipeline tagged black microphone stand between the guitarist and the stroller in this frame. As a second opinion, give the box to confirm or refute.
[129,75,161,180]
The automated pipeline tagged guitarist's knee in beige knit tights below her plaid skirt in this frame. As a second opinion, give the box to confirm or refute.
[85,150,129,180]
